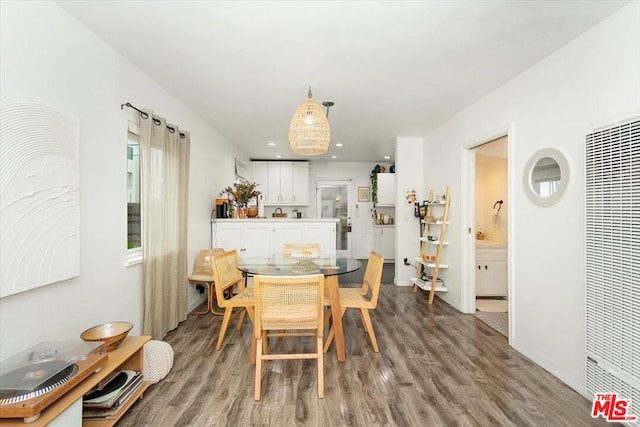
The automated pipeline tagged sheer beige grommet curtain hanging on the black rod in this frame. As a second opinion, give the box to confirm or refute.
[140,110,190,339]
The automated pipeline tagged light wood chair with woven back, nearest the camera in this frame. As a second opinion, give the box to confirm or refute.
[254,274,324,400]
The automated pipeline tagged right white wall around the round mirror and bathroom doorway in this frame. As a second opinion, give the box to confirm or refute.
[424,2,640,393]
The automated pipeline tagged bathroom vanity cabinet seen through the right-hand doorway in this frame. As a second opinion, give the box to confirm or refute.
[476,248,507,297]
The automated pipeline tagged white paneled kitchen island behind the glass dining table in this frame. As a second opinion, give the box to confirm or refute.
[212,218,339,258]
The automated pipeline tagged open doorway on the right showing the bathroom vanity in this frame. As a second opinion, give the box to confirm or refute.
[468,136,510,337]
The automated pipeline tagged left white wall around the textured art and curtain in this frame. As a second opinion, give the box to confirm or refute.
[0,1,240,359]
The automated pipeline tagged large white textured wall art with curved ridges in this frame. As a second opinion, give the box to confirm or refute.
[0,97,80,298]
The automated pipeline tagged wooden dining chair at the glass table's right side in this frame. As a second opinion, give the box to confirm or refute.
[324,251,384,353]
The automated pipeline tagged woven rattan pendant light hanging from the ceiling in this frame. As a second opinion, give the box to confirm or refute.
[289,88,331,156]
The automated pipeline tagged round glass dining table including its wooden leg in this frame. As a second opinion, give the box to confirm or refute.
[238,256,362,362]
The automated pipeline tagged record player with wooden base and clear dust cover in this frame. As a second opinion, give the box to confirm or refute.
[0,341,108,424]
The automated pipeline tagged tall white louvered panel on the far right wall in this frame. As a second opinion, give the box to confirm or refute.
[586,121,640,415]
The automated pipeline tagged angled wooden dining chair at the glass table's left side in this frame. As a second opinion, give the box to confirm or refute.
[212,249,255,363]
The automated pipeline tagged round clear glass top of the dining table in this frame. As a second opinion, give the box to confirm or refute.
[238,256,362,276]
